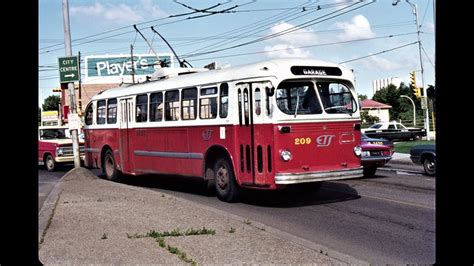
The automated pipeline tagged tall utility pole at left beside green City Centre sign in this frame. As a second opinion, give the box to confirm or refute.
[63,0,81,168]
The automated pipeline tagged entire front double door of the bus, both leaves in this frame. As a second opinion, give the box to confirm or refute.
[235,82,273,187]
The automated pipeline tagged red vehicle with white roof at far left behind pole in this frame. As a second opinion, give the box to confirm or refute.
[38,126,84,171]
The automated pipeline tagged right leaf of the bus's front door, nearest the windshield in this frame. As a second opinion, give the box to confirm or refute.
[250,82,274,186]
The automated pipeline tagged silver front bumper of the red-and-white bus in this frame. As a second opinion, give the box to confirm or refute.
[275,167,364,185]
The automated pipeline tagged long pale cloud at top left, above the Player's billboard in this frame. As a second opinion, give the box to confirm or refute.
[70,0,166,25]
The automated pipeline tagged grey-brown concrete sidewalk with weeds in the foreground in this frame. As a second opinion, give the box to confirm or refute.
[39,168,367,265]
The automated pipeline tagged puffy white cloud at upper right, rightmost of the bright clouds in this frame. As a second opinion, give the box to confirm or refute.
[335,15,375,41]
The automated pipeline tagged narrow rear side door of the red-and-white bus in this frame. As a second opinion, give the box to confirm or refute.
[119,98,134,172]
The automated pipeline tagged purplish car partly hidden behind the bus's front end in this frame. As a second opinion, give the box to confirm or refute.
[361,133,393,177]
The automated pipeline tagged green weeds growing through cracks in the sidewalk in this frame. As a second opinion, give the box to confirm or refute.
[127,227,215,265]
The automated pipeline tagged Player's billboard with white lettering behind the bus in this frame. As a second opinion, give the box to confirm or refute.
[85,54,173,78]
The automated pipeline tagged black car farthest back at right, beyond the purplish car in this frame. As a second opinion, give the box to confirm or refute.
[362,122,426,140]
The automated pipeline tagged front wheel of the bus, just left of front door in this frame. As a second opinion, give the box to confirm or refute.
[214,159,239,202]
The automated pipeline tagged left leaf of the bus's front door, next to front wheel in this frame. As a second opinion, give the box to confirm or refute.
[234,83,255,186]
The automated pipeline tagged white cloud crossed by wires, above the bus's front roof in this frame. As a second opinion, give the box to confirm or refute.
[264,22,317,58]
